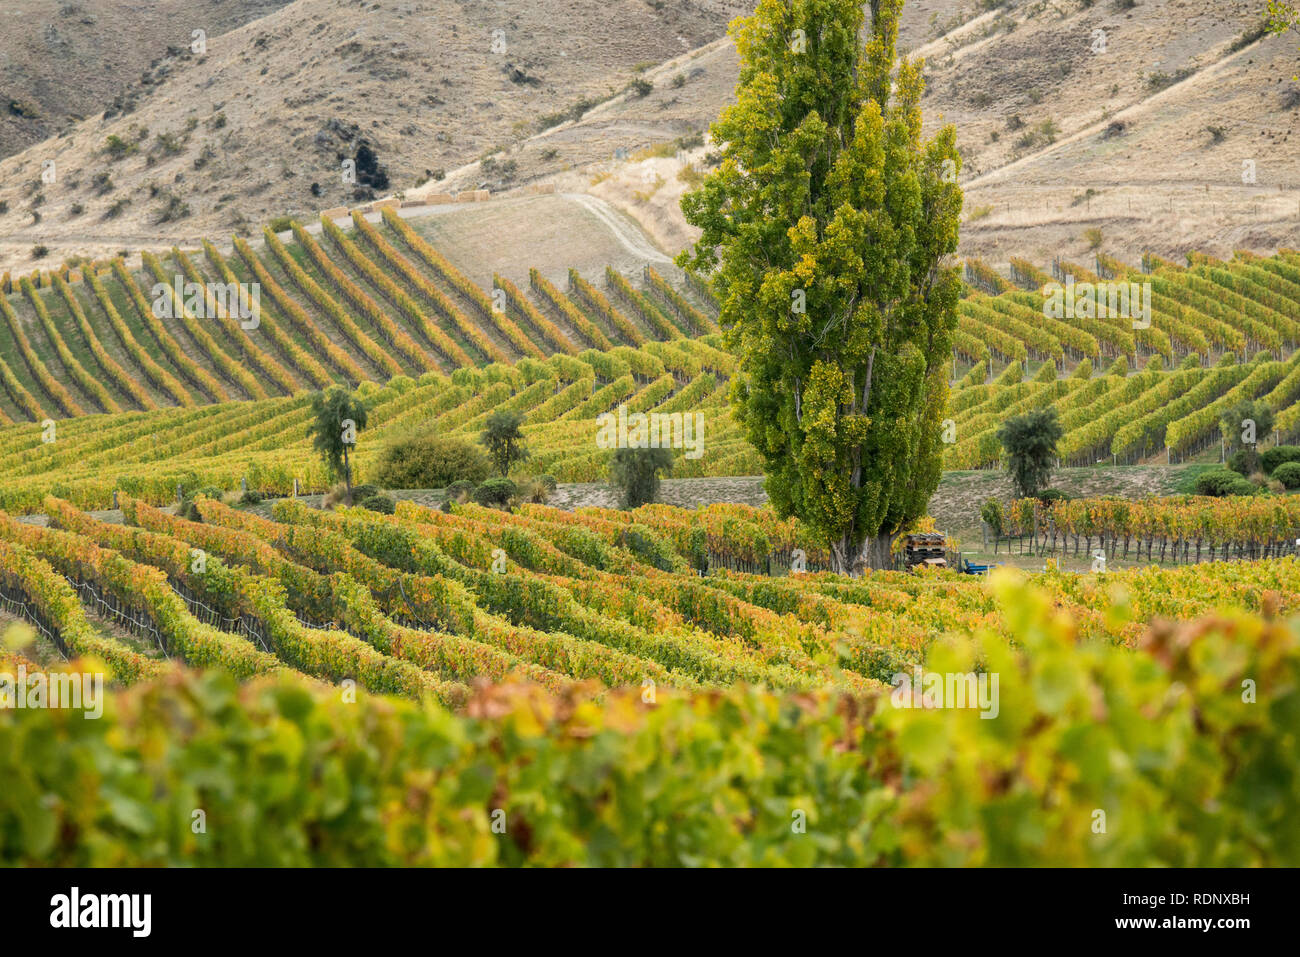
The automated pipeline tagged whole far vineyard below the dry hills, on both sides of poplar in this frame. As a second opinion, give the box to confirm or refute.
[0,243,1300,512]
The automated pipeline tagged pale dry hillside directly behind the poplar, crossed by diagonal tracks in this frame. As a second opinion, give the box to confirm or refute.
[431,0,1300,264]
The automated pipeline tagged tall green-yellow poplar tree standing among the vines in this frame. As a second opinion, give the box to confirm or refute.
[677,0,962,575]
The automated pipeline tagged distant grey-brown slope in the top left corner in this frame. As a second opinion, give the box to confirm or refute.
[0,0,290,157]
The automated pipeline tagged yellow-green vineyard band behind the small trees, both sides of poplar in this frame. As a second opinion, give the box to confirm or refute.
[0,337,1300,512]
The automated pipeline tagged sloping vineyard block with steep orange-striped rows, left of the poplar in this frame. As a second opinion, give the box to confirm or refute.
[0,211,716,424]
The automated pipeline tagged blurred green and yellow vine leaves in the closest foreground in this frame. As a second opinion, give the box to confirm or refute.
[0,572,1300,866]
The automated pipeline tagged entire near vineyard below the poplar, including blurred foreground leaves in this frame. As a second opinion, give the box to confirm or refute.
[0,498,1300,866]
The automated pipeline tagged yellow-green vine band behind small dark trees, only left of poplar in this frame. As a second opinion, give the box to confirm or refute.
[0,337,743,511]
